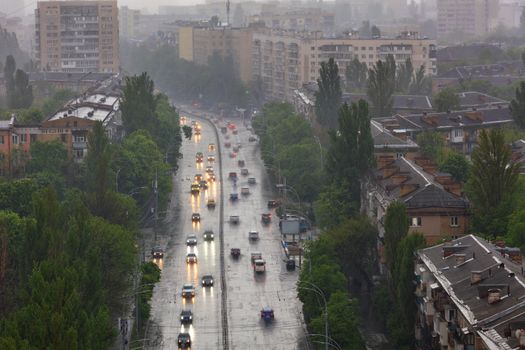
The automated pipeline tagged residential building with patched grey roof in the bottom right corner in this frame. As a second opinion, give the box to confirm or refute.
[415,235,525,350]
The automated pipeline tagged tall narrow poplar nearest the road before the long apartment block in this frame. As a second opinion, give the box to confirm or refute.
[315,57,342,129]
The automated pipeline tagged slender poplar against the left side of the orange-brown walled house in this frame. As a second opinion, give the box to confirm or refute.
[384,201,408,278]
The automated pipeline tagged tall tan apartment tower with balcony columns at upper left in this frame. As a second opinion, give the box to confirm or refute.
[35,0,120,73]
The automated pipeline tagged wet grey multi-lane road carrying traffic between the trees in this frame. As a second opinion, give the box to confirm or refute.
[147,113,305,350]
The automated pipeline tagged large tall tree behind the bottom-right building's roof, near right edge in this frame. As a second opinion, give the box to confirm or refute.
[468,129,520,235]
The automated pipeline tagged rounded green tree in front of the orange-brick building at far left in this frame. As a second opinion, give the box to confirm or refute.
[28,140,68,175]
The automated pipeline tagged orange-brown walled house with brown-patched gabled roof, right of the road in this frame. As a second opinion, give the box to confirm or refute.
[361,152,469,244]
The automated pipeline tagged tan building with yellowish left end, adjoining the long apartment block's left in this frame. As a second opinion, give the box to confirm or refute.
[179,25,253,83]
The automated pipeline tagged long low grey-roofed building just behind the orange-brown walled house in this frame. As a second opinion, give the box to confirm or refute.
[376,105,514,155]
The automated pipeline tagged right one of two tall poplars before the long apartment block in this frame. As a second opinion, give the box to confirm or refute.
[367,55,395,118]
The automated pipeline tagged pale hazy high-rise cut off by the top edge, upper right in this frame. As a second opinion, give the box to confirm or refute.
[437,0,499,42]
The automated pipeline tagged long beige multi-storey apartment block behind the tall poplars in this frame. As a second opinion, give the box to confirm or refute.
[253,29,437,101]
